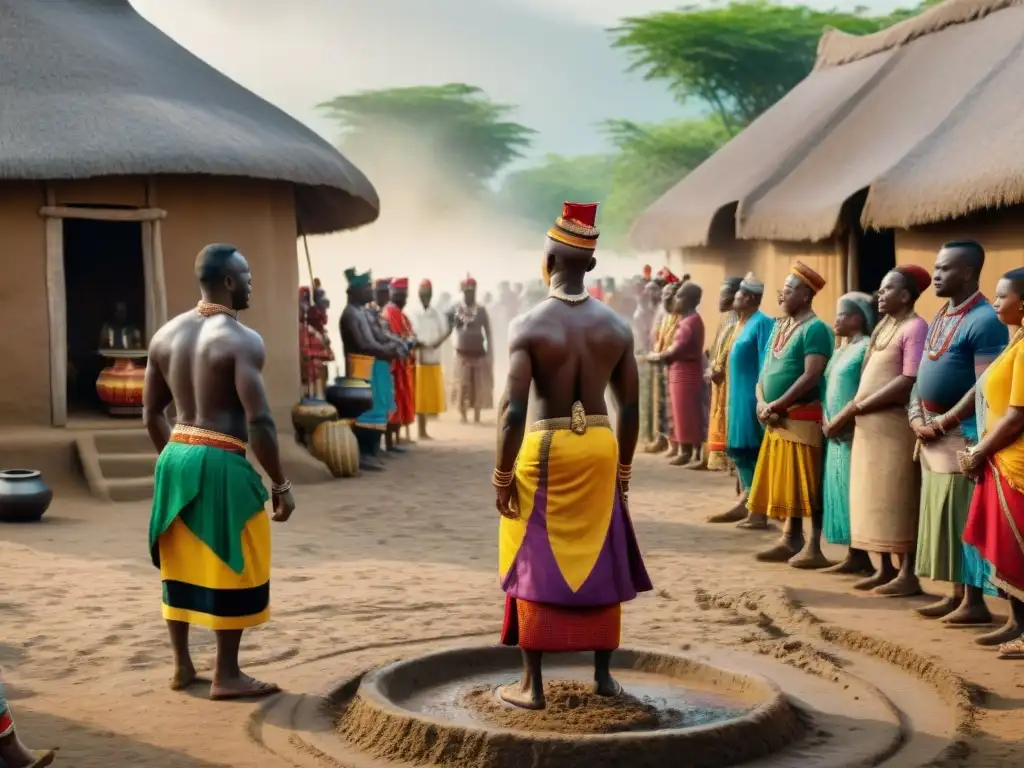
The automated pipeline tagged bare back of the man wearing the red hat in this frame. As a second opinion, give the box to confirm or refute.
[509,298,633,419]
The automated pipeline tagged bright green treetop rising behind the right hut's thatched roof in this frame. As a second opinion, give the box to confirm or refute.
[609,0,935,135]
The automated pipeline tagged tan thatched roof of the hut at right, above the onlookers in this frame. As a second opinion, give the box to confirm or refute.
[635,0,1024,248]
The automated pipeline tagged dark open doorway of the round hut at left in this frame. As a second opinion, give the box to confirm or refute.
[62,218,146,415]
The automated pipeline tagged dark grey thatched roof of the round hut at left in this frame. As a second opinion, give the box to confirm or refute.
[0,0,380,234]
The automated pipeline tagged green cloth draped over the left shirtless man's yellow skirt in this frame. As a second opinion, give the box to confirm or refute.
[150,442,269,573]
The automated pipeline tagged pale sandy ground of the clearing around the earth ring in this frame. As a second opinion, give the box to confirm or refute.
[0,419,1024,768]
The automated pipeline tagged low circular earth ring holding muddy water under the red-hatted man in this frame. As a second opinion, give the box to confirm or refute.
[332,647,806,768]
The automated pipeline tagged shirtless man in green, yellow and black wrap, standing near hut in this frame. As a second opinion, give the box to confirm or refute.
[143,244,295,699]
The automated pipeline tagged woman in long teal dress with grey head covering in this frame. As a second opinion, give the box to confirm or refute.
[821,293,878,573]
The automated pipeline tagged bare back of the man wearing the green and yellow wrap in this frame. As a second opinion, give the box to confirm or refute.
[150,310,265,441]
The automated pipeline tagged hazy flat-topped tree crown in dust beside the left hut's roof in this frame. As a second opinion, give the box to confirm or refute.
[319,83,535,189]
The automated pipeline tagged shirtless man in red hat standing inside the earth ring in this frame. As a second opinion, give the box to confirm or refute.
[493,203,651,710]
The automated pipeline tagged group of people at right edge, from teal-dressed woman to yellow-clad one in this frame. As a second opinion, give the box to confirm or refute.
[822,247,1024,658]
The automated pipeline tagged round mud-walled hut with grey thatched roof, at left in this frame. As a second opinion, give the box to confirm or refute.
[0,0,379,487]
